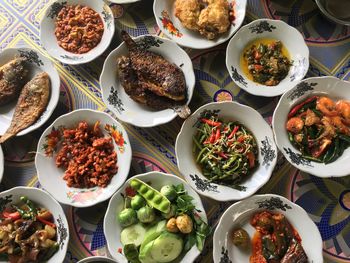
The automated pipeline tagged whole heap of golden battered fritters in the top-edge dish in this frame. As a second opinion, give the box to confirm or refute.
[175,0,231,39]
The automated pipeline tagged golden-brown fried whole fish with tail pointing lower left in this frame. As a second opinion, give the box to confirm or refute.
[0,72,51,143]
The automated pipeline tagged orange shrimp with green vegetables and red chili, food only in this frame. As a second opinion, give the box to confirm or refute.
[286,96,350,164]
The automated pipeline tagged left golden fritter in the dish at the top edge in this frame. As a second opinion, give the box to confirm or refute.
[175,0,201,31]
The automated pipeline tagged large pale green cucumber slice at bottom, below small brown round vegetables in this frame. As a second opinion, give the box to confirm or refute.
[151,231,183,263]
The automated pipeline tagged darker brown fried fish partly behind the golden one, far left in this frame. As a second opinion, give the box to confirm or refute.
[0,57,28,106]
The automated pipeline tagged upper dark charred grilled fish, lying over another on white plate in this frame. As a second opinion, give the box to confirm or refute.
[122,31,186,101]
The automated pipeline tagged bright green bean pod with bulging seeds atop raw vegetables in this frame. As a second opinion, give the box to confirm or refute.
[130,178,170,213]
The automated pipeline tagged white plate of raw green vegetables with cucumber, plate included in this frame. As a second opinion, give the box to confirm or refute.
[103,171,210,263]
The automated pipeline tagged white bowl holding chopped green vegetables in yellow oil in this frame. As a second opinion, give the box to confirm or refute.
[226,19,309,97]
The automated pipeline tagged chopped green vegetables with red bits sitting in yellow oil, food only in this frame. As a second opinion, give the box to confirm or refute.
[243,41,291,86]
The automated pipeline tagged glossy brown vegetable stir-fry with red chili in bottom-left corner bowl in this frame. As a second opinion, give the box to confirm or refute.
[0,196,59,262]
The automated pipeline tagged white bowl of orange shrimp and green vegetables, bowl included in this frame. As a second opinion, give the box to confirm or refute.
[272,77,350,177]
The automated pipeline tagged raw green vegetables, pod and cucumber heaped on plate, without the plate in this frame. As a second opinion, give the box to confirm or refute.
[117,178,210,263]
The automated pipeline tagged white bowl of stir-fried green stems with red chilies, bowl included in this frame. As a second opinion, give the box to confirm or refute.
[175,102,277,201]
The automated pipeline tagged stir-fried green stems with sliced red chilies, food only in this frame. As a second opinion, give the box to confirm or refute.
[193,112,258,190]
